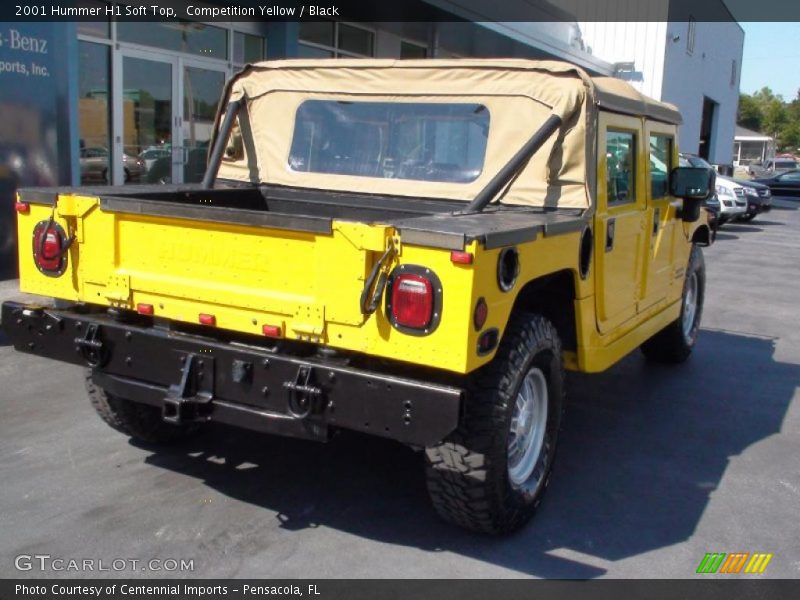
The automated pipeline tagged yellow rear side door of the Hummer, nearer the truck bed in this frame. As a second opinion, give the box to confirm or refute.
[595,112,649,334]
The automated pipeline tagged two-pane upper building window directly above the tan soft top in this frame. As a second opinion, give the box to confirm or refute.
[297,21,375,58]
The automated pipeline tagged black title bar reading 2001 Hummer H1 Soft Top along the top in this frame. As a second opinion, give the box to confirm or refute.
[0,0,800,22]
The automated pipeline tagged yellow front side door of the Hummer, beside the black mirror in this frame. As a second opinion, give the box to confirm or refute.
[637,121,677,312]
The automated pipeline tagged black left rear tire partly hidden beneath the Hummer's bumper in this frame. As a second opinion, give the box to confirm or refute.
[85,369,198,444]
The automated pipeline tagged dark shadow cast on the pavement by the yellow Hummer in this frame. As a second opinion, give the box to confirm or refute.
[138,330,800,578]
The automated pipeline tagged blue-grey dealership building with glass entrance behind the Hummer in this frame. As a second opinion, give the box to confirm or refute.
[0,0,744,274]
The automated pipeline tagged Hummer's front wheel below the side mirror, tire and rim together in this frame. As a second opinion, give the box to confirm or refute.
[642,246,706,363]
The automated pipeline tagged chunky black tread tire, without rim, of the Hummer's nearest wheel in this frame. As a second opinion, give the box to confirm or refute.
[425,314,564,534]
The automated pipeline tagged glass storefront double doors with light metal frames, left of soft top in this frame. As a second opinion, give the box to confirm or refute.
[112,49,227,185]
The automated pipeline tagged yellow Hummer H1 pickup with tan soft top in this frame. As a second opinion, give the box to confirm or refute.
[2,60,714,532]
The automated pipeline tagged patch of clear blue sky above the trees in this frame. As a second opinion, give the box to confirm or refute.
[739,22,800,101]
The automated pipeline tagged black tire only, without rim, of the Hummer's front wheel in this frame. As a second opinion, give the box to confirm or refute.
[642,246,706,364]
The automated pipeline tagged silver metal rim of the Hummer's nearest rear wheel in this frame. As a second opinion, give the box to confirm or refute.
[508,367,548,488]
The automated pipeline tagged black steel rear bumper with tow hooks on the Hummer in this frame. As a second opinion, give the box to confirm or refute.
[2,302,463,446]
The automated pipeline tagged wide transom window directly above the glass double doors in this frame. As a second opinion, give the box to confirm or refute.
[117,21,228,60]
